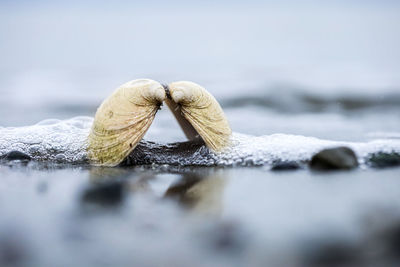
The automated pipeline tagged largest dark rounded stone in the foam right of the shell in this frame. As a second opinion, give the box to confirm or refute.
[309,147,358,171]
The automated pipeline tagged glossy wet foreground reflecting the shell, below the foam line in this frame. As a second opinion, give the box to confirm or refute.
[0,161,400,266]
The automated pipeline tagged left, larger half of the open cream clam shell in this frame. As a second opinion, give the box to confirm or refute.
[87,79,165,166]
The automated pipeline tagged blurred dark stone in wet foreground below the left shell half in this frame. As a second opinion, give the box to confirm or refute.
[81,181,125,206]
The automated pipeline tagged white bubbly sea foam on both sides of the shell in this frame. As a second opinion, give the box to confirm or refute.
[0,117,400,166]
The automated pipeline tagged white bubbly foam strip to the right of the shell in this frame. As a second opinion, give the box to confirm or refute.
[218,133,400,165]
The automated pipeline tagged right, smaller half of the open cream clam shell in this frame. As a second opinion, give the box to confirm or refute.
[165,81,232,152]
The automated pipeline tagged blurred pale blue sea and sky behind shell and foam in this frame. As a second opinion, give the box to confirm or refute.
[0,0,400,141]
